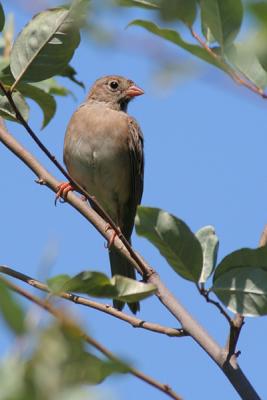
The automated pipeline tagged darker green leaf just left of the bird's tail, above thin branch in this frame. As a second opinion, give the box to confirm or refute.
[64,271,118,298]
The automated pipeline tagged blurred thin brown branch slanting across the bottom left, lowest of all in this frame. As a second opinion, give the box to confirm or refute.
[0,277,182,400]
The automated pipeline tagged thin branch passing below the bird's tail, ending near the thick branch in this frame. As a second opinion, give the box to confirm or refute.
[0,265,187,337]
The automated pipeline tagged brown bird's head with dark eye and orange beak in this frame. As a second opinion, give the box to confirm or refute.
[87,75,144,111]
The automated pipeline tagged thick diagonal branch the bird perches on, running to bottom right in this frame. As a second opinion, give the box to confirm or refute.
[0,115,260,400]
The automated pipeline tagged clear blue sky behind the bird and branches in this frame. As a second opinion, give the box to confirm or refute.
[0,0,267,400]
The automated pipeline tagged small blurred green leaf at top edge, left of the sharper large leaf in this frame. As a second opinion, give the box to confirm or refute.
[160,0,197,26]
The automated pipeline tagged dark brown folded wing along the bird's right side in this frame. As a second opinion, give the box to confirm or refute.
[123,117,144,239]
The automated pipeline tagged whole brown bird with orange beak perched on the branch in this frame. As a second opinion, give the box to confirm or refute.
[57,75,144,314]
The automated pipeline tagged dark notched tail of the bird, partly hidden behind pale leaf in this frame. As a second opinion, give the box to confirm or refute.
[109,248,140,314]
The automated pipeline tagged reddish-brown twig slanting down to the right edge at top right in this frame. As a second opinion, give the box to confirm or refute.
[188,26,267,99]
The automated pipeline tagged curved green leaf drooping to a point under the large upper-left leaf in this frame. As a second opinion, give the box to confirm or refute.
[18,83,57,128]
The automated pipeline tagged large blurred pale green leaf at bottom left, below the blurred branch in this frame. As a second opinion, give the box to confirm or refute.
[27,325,129,388]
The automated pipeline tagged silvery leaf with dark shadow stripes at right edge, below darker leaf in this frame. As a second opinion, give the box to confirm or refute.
[214,266,267,317]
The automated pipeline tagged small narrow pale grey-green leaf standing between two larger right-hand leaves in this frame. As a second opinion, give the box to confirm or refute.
[196,226,219,283]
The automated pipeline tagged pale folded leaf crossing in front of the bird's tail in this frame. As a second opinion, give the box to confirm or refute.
[111,275,157,303]
